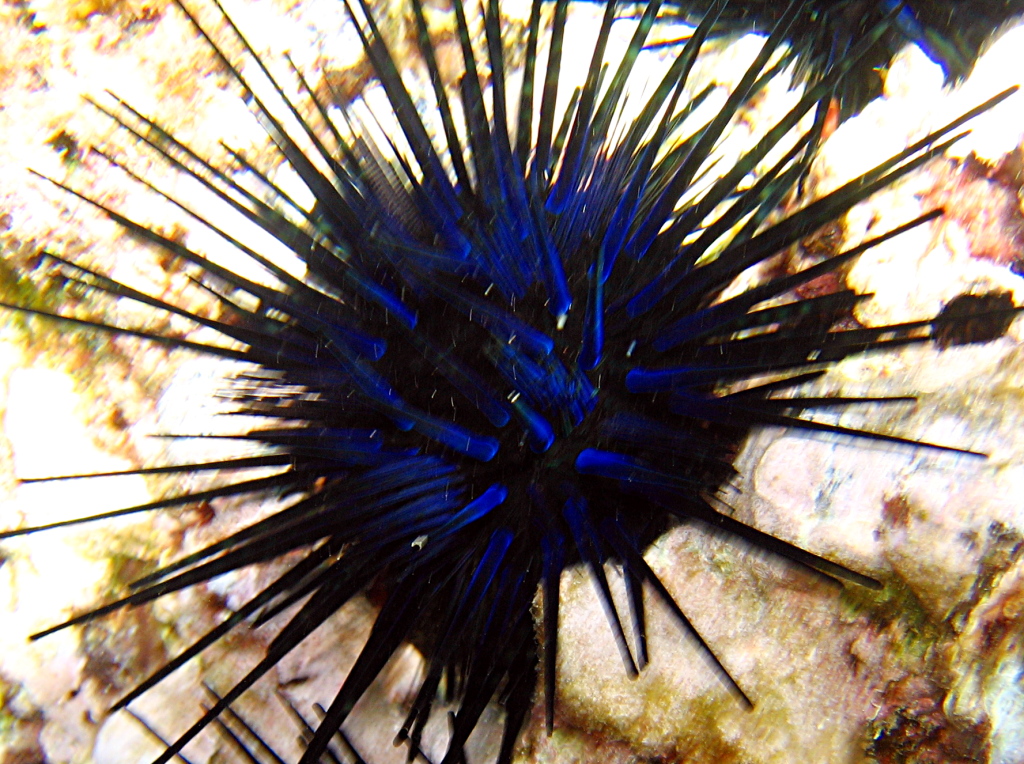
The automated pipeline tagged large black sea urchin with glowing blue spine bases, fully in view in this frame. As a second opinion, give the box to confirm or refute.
[3,0,1015,763]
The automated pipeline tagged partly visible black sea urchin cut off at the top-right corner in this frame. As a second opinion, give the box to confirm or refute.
[651,0,1024,117]
